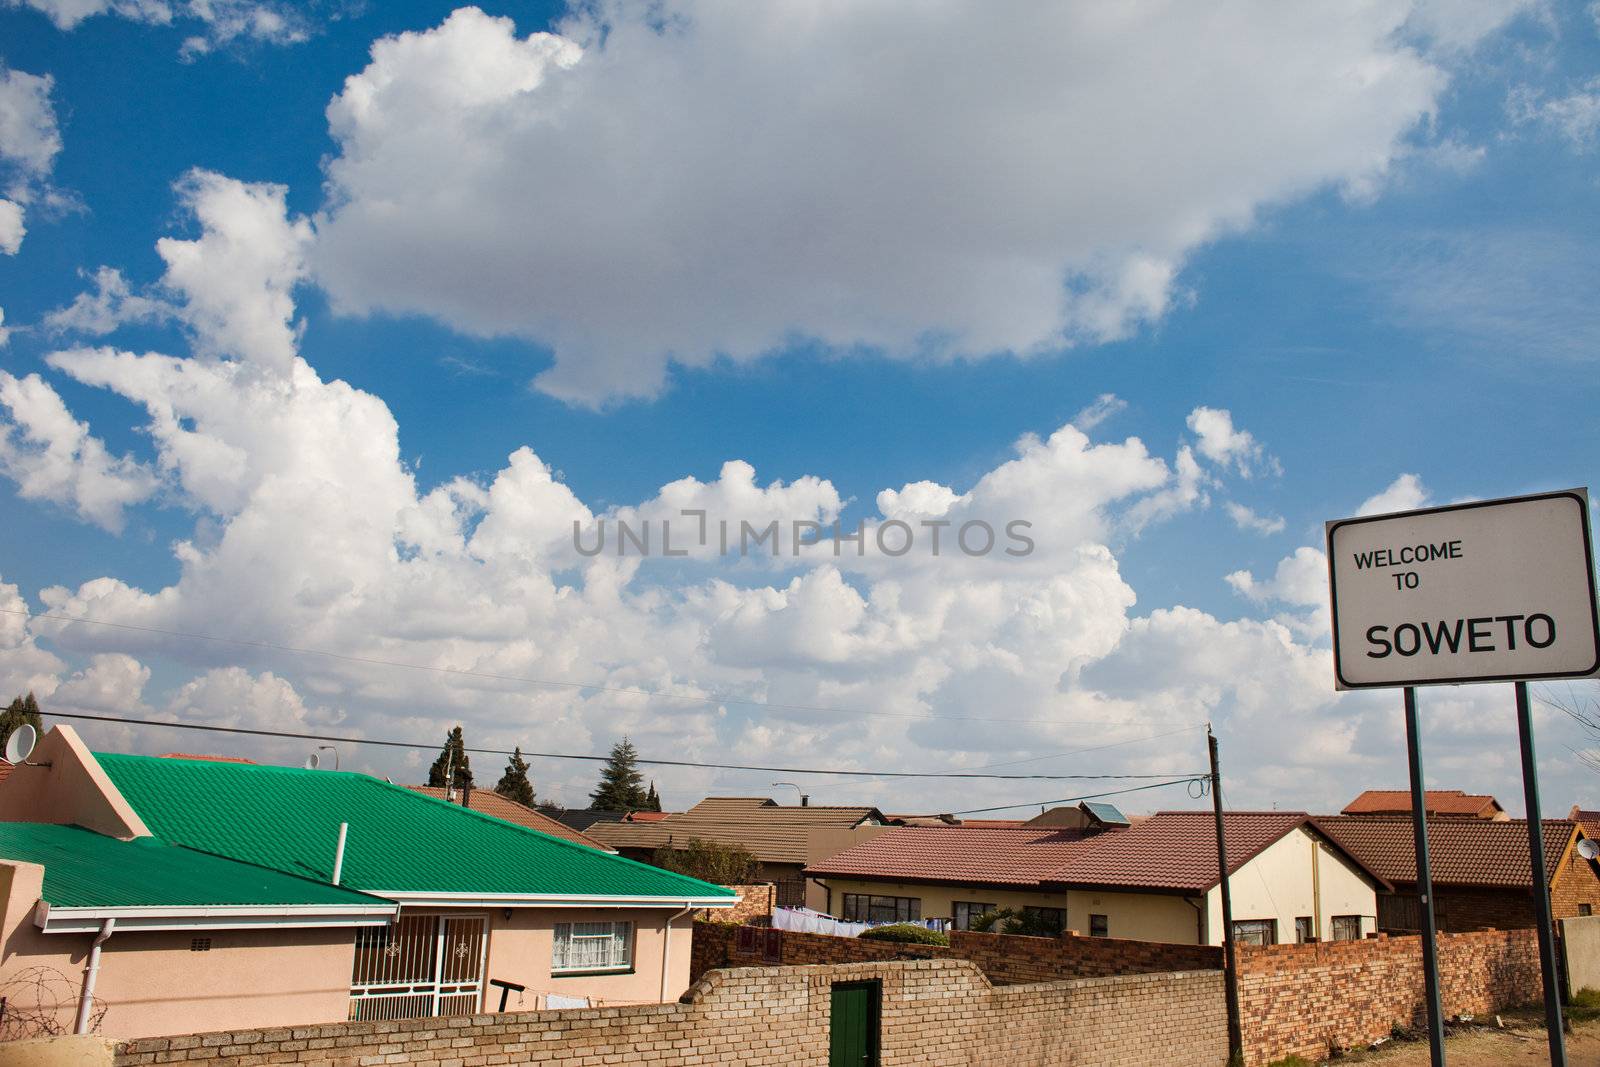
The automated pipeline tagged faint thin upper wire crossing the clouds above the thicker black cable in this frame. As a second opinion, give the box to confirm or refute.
[0,608,1203,726]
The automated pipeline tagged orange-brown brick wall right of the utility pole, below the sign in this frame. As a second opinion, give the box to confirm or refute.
[1238,929,1542,1064]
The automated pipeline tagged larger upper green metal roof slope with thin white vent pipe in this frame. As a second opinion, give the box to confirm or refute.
[96,753,734,901]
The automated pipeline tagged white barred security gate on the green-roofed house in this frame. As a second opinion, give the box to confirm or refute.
[350,915,488,1021]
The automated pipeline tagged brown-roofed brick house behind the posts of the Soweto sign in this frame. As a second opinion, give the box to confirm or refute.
[1318,816,1600,933]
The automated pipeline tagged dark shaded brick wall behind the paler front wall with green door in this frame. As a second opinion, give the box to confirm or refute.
[690,923,1222,985]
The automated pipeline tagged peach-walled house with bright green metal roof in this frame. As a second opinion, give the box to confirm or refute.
[0,726,738,1037]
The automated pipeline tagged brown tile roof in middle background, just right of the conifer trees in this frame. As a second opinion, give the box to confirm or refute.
[589,797,883,864]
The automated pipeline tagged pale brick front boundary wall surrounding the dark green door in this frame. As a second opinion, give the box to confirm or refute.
[115,960,1227,1067]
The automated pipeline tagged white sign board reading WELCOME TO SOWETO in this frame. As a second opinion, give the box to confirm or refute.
[1328,490,1600,689]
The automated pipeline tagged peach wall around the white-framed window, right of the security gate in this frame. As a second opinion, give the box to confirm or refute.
[483,907,694,1011]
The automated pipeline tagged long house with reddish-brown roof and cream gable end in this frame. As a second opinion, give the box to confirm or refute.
[806,811,1389,944]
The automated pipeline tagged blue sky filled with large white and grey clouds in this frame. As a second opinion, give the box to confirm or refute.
[0,0,1600,814]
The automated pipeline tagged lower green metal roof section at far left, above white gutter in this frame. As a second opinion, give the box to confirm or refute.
[0,822,387,907]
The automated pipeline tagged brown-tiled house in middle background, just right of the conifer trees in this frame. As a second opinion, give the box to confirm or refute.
[587,797,888,909]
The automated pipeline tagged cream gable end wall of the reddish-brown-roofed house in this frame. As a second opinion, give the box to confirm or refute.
[1206,829,1378,945]
